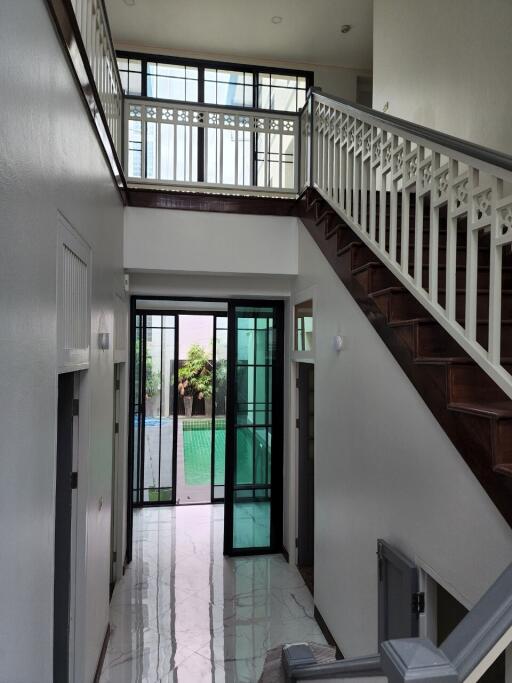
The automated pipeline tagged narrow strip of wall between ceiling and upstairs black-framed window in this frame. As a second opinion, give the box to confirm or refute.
[116,42,371,101]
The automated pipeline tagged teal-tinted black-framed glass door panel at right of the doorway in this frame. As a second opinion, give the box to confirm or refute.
[224,301,283,555]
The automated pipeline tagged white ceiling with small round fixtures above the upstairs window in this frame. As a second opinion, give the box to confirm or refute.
[106,0,373,70]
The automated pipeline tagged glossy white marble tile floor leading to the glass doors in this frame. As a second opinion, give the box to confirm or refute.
[100,505,325,683]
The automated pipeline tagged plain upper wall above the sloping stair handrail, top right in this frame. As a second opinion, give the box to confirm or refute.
[373,0,512,154]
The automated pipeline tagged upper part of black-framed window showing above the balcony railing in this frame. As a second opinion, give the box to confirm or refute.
[117,52,313,112]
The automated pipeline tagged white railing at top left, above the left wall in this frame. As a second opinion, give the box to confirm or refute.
[71,0,123,158]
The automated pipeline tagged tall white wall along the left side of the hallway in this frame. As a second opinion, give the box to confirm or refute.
[0,0,123,683]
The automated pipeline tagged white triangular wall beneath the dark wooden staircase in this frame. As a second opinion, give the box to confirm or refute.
[288,227,512,656]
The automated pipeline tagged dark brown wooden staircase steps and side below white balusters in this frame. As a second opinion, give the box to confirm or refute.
[297,189,512,526]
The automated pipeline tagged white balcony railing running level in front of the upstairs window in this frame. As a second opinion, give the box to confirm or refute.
[125,98,299,195]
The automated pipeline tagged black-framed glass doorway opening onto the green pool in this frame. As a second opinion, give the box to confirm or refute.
[128,297,283,556]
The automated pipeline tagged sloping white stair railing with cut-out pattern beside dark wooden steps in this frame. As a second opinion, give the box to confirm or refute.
[301,92,512,398]
